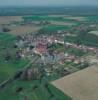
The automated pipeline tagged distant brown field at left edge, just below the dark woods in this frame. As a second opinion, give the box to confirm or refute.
[0,16,22,24]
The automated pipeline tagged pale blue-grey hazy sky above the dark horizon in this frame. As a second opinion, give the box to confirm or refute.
[0,0,98,6]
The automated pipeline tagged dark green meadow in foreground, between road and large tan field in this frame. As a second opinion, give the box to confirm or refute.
[0,80,71,100]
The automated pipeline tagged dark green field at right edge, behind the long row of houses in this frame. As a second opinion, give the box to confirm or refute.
[65,33,98,46]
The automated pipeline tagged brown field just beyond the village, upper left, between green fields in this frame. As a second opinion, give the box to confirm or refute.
[8,25,41,35]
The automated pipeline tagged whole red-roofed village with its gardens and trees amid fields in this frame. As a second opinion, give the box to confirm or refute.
[14,25,98,79]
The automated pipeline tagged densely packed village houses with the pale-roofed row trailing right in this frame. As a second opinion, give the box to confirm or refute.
[15,31,97,64]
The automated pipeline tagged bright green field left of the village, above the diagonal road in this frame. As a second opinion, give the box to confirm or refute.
[0,33,28,83]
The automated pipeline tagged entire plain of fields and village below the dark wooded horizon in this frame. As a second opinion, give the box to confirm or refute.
[0,12,98,100]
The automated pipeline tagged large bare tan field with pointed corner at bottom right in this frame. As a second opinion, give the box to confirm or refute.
[52,66,98,100]
